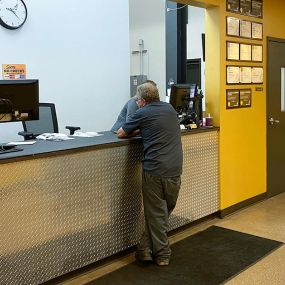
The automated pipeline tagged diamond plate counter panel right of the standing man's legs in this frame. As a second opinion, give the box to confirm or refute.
[170,132,219,229]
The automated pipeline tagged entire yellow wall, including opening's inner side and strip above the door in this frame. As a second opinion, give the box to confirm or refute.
[173,0,285,210]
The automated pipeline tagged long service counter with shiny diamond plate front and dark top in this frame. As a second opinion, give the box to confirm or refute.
[0,128,219,285]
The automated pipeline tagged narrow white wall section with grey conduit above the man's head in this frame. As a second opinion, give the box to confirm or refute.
[129,0,166,100]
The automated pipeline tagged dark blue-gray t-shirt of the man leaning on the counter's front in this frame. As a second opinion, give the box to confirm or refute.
[122,102,183,177]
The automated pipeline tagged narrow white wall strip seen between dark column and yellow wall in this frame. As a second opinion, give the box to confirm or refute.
[187,6,205,95]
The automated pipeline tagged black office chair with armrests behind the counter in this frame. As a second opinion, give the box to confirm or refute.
[18,103,80,140]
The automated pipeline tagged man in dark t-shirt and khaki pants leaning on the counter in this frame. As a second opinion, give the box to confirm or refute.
[117,83,183,265]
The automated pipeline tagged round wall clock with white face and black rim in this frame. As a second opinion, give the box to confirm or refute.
[0,0,27,30]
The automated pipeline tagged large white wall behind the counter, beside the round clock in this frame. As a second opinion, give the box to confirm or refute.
[0,0,129,142]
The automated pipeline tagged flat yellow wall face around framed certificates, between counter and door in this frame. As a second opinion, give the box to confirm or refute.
[220,1,266,209]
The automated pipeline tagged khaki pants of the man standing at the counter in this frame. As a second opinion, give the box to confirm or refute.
[138,171,181,259]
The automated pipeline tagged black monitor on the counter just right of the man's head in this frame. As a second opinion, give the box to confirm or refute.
[169,84,197,113]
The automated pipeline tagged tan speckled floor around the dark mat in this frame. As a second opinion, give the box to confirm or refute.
[59,193,285,285]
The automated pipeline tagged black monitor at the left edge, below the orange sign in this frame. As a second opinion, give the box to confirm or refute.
[0,79,39,123]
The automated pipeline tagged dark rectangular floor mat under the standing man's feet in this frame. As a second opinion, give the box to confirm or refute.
[88,226,283,285]
